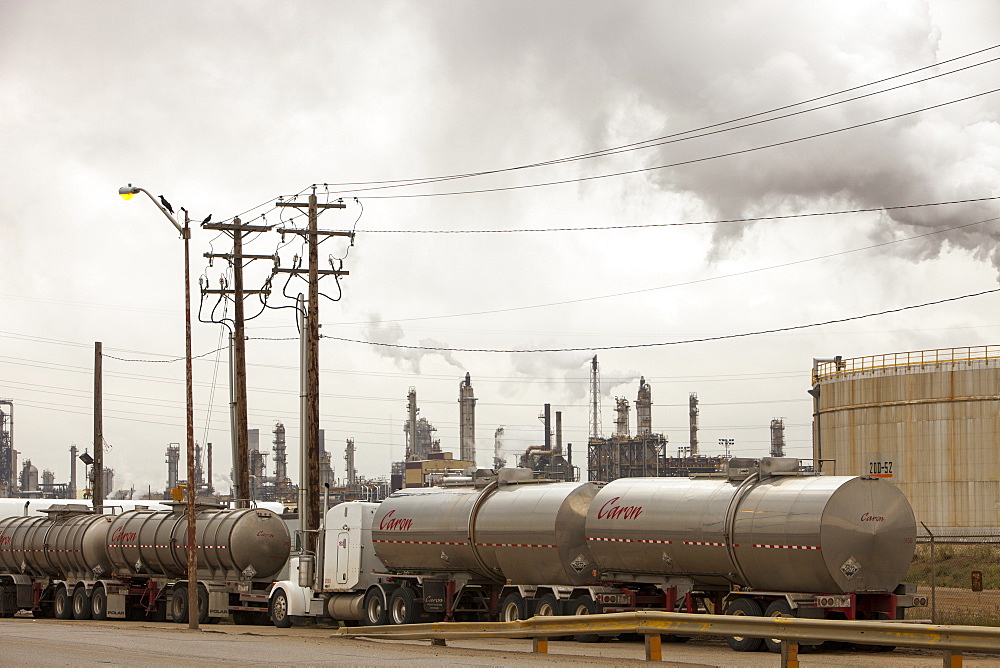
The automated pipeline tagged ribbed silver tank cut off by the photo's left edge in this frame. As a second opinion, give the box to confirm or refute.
[0,506,114,578]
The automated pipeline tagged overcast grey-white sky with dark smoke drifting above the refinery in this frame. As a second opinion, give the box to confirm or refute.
[0,0,1000,492]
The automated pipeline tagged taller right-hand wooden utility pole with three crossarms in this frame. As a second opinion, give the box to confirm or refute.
[274,187,354,550]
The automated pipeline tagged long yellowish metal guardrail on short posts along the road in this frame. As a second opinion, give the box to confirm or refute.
[337,612,1000,666]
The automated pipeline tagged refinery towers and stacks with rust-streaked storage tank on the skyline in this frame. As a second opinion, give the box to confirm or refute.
[0,347,1000,535]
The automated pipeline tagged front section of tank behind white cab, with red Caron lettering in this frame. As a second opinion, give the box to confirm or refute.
[372,486,488,580]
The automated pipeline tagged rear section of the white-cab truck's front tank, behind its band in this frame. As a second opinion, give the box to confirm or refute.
[474,482,597,585]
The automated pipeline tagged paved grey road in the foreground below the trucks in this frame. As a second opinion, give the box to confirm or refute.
[0,618,1000,668]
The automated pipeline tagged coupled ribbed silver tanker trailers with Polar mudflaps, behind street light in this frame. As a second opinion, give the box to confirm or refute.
[0,504,290,622]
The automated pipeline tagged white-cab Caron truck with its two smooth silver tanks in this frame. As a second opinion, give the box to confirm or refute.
[271,458,926,651]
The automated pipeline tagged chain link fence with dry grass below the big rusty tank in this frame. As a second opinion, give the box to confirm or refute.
[904,530,1000,626]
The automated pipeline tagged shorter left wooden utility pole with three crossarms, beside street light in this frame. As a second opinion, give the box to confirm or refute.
[201,218,274,508]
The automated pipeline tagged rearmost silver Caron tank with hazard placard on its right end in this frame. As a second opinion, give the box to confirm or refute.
[586,474,916,593]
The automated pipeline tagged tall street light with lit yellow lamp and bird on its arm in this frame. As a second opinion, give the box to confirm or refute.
[118,183,201,630]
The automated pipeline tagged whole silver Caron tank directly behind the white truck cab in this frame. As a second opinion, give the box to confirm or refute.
[372,469,597,585]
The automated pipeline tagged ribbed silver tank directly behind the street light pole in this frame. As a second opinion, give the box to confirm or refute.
[107,504,291,579]
